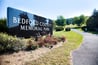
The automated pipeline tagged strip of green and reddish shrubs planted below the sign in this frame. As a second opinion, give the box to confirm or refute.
[0,33,66,53]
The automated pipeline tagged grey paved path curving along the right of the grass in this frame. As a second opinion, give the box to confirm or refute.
[72,29,98,65]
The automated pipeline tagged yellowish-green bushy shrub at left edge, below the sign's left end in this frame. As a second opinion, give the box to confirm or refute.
[0,33,23,52]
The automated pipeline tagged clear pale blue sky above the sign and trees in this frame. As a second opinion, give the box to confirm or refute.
[0,0,98,19]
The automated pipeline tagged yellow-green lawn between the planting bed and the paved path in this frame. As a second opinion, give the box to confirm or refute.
[29,31,83,65]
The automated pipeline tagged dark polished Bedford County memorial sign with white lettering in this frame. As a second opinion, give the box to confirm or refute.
[7,7,53,38]
